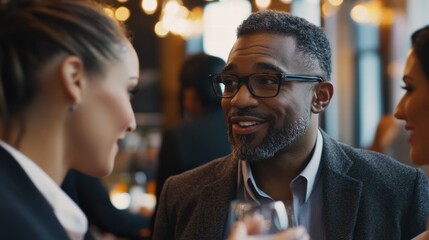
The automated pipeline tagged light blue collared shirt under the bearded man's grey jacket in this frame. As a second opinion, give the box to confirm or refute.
[239,130,325,239]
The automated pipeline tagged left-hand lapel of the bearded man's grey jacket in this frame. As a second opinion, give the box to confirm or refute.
[197,157,238,239]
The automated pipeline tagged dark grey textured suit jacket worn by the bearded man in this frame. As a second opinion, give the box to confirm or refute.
[153,133,429,240]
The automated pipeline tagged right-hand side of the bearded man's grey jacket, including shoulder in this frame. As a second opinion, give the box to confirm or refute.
[320,133,429,239]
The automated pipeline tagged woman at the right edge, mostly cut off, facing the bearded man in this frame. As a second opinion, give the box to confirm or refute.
[394,25,429,239]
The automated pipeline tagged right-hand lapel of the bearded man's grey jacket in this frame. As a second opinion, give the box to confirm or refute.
[321,133,362,239]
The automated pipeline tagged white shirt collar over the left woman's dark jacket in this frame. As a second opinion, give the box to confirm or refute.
[0,140,88,240]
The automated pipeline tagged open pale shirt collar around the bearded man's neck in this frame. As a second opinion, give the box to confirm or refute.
[240,130,323,201]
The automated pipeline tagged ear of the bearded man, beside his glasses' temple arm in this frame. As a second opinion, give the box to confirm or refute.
[311,82,334,114]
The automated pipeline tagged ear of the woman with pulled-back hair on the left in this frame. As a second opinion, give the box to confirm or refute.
[60,56,85,105]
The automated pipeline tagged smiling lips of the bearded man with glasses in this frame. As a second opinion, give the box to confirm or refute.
[230,116,266,135]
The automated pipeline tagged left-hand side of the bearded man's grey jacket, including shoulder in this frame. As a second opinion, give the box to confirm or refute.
[153,155,238,240]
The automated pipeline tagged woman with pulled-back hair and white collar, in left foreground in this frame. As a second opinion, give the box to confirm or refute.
[0,0,139,239]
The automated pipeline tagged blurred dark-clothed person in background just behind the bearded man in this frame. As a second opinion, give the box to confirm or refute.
[156,53,231,204]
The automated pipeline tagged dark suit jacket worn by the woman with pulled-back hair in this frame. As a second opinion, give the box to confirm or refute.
[0,147,68,240]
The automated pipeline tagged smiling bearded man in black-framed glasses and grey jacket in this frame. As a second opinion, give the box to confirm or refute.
[154,10,429,239]
